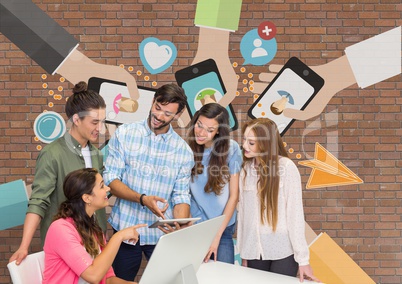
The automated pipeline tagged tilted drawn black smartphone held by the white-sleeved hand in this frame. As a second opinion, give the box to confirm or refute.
[248,57,324,136]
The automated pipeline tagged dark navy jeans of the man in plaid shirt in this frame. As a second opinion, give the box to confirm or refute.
[112,233,155,281]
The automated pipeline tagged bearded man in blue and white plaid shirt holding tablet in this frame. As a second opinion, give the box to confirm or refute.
[104,84,194,281]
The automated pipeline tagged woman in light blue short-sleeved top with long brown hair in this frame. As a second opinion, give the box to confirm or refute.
[188,103,242,263]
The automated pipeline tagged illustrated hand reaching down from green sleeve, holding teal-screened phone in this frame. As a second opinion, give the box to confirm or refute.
[178,27,238,127]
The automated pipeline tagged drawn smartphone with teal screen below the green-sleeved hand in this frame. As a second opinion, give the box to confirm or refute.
[175,59,238,131]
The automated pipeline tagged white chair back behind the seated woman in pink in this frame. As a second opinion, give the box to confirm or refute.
[7,251,45,284]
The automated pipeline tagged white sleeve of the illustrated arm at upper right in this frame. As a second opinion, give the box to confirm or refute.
[345,26,401,88]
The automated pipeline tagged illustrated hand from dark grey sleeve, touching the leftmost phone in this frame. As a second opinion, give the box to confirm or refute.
[57,50,140,102]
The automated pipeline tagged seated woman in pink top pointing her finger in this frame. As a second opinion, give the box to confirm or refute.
[43,168,146,284]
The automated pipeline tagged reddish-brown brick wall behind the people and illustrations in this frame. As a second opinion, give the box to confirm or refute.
[0,0,402,283]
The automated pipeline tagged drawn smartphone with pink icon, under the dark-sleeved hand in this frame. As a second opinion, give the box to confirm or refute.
[88,77,156,124]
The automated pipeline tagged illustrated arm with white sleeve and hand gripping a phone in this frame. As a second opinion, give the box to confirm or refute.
[254,26,401,120]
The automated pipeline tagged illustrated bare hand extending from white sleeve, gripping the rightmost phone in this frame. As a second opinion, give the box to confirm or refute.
[253,55,356,120]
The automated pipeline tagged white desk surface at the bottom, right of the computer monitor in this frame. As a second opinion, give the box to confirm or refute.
[197,261,316,284]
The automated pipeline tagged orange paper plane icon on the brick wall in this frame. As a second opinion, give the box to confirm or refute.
[299,142,363,189]
